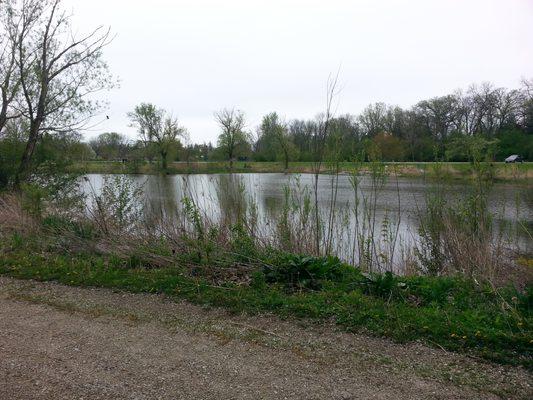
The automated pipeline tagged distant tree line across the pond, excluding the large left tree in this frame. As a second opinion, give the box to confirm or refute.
[89,80,533,168]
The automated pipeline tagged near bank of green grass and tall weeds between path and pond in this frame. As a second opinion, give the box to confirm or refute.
[0,164,533,370]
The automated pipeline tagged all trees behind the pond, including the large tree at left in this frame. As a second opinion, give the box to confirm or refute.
[0,0,533,191]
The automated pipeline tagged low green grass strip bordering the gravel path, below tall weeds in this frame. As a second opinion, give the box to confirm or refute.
[0,233,533,369]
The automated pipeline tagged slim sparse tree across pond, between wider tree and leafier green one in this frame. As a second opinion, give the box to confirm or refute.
[215,108,247,168]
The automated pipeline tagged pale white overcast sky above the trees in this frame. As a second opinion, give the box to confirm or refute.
[65,0,533,143]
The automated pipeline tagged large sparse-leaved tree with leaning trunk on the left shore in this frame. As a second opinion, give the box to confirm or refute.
[15,0,113,183]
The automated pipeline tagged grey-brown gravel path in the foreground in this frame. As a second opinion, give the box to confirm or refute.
[0,277,533,400]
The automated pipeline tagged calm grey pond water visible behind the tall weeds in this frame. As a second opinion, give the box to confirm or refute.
[83,173,533,270]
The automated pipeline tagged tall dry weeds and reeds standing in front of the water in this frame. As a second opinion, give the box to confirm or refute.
[3,154,527,288]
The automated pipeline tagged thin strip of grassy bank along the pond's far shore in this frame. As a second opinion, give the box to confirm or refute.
[67,161,533,181]
